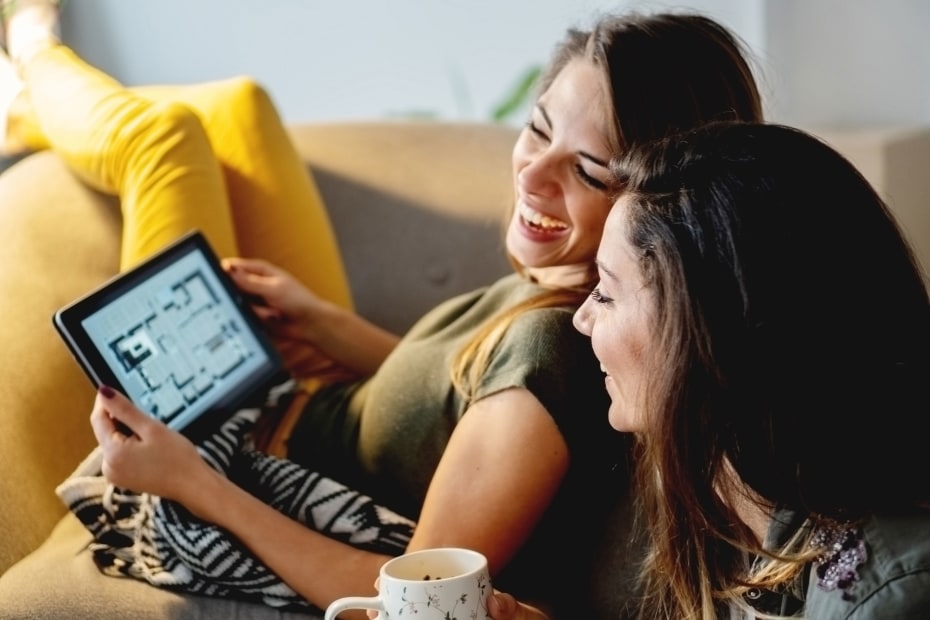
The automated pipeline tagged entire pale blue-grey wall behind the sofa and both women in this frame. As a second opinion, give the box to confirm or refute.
[63,0,930,125]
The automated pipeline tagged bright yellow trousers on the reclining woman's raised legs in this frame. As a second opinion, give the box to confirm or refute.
[15,46,352,308]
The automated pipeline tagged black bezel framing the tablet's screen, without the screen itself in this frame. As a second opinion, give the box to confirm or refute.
[53,231,288,438]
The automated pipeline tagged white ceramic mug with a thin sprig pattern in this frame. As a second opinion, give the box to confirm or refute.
[325,547,491,620]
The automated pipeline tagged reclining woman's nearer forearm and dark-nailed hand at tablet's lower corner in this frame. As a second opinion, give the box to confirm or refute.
[90,386,389,619]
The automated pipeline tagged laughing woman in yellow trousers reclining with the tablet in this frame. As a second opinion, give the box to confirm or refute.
[5,0,761,615]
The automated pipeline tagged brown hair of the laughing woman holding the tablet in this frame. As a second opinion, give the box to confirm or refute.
[452,13,762,402]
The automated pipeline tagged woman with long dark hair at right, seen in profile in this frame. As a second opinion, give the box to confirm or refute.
[491,123,930,620]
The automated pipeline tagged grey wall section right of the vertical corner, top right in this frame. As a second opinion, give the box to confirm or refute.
[763,0,930,126]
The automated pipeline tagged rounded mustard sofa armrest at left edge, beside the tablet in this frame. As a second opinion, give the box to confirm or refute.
[0,153,120,572]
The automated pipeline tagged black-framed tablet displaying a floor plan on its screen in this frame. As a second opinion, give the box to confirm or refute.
[53,231,287,436]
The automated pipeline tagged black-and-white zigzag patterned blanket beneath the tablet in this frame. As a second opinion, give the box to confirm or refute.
[56,392,415,611]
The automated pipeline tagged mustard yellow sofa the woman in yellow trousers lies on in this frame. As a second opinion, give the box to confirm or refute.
[0,121,516,620]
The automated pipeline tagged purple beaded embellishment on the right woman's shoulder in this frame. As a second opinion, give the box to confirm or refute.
[811,523,869,601]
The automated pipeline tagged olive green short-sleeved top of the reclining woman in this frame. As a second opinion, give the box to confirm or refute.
[288,274,623,616]
